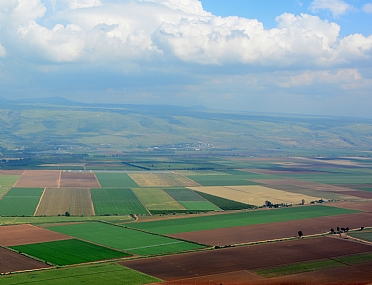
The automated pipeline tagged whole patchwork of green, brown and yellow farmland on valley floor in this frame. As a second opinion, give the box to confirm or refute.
[0,157,372,285]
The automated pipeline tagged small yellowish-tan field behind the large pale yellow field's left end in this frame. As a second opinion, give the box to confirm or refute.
[128,173,200,187]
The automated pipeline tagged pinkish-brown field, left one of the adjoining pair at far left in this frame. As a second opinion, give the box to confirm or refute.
[14,170,61,188]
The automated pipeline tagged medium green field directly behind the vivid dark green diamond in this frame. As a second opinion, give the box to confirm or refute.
[48,222,205,255]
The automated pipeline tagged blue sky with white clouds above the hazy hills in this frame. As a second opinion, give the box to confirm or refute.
[0,0,372,118]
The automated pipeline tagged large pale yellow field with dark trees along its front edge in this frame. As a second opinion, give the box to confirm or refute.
[189,185,320,206]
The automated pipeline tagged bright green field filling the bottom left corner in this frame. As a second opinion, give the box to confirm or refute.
[0,263,161,285]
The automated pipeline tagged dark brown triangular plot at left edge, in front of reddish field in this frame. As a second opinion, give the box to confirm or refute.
[0,247,49,272]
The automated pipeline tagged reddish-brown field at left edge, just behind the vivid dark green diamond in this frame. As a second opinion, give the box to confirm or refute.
[0,225,71,245]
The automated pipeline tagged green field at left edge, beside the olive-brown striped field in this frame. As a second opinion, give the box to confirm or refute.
[0,188,44,216]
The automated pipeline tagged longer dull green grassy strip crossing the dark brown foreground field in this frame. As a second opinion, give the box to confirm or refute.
[252,259,344,278]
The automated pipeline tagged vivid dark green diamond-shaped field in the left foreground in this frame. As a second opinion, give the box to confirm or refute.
[10,239,130,265]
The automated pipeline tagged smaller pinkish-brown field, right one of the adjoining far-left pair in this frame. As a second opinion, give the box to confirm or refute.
[60,172,100,188]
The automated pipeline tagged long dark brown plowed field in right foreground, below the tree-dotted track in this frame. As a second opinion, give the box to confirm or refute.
[120,237,372,284]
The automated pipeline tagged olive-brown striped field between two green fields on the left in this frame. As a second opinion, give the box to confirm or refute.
[35,188,93,216]
